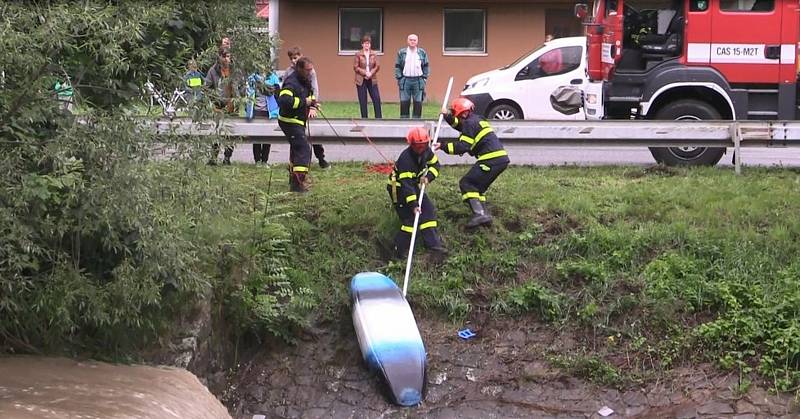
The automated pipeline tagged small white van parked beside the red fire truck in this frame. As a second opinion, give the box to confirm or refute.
[461,36,586,119]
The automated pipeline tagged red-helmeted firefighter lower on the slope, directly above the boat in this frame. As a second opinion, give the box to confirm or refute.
[386,127,447,258]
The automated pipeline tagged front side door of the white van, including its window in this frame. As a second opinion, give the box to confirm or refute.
[514,46,586,119]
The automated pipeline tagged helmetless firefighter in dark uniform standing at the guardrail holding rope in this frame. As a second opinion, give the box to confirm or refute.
[278,57,317,192]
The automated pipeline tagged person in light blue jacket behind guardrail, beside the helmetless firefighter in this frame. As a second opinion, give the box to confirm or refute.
[245,66,281,164]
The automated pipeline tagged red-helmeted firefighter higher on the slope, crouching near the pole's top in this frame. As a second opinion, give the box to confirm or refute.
[436,97,510,228]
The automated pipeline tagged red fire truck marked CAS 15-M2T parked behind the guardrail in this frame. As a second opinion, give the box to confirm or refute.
[575,0,800,165]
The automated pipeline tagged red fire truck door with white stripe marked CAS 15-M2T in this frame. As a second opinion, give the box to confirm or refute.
[712,0,782,84]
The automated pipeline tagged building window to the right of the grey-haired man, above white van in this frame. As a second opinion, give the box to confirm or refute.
[444,9,486,53]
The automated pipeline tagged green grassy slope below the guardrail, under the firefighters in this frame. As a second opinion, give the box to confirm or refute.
[194,162,800,390]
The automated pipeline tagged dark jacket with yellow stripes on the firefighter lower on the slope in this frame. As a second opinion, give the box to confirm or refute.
[387,147,439,208]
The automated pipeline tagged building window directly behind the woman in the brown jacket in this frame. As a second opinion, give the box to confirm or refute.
[339,8,383,52]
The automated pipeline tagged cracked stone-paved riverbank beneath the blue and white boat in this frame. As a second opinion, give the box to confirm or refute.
[225,320,800,419]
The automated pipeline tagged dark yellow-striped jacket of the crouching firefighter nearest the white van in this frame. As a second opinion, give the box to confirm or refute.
[441,112,508,161]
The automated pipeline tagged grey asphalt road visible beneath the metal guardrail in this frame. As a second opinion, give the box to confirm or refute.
[223,143,800,167]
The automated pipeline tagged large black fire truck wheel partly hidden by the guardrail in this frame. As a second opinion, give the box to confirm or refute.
[650,99,725,166]
